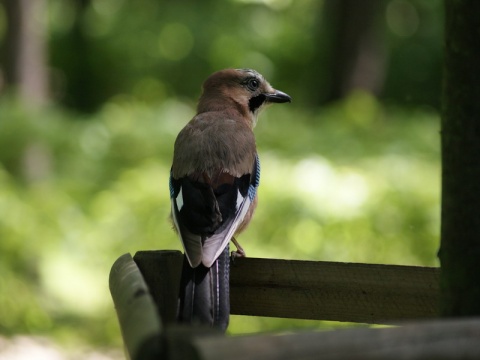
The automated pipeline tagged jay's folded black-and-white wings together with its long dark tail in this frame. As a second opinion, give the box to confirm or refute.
[170,156,260,330]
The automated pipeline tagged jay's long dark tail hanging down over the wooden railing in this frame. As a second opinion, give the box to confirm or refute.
[178,245,230,331]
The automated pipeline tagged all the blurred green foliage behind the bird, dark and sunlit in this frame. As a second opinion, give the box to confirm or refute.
[0,0,442,352]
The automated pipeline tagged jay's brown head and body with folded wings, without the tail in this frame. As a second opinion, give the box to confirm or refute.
[170,69,290,267]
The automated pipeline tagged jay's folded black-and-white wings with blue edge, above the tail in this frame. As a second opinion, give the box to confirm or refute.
[170,156,260,267]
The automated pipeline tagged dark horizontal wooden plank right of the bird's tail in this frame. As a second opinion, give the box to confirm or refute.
[230,258,439,324]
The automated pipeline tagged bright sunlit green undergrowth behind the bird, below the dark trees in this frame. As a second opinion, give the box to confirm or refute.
[0,92,439,345]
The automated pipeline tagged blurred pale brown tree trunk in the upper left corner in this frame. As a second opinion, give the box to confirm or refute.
[5,0,48,105]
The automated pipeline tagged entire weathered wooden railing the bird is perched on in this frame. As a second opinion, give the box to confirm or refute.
[110,251,480,360]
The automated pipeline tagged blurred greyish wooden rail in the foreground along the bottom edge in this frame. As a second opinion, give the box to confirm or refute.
[192,318,480,360]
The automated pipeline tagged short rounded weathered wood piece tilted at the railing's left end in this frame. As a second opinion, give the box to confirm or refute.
[109,254,165,360]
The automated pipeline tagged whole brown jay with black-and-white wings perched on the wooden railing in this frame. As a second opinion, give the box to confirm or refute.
[169,69,291,331]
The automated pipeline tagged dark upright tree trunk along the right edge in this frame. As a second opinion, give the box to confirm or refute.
[439,0,480,316]
